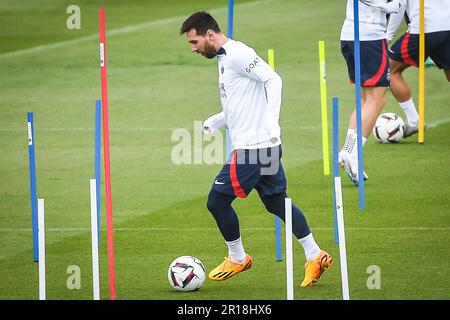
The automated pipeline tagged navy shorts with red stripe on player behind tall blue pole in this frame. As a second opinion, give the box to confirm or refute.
[341,39,390,87]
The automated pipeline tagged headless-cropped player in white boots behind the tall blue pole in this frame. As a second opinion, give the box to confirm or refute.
[339,0,404,185]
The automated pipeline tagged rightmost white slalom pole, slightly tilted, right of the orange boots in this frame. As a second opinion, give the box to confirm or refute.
[334,177,350,300]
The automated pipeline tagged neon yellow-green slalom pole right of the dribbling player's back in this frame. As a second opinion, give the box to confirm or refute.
[319,40,330,176]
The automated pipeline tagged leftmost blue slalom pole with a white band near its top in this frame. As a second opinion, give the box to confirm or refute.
[27,112,39,262]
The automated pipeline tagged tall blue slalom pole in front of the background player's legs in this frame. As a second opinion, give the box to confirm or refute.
[353,1,365,211]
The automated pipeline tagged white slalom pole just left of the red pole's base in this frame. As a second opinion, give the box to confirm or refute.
[90,179,100,300]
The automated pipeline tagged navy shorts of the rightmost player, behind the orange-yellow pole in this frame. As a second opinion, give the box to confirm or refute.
[389,31,450,69]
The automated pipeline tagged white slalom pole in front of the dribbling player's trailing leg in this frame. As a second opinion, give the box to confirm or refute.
[284,198,294,300]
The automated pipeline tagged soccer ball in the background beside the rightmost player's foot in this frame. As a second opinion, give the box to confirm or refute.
[373,112,405,143]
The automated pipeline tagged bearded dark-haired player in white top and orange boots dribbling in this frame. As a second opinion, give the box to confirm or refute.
[180,12,333,287]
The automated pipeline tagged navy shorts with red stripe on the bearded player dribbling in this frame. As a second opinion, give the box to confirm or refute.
[212,145,286,198]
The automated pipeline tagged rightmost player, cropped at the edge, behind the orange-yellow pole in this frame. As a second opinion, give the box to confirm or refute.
[386,0,450,137]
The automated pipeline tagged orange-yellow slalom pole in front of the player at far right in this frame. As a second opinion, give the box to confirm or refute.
[418,0,425,143]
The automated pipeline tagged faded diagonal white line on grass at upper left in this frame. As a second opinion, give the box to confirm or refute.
[0,0,273,58]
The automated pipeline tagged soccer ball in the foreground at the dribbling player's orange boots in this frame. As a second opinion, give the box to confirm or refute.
[167,256,206,291]
